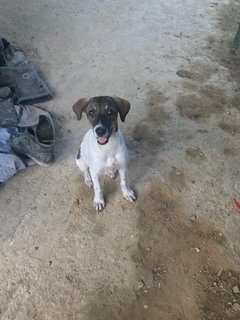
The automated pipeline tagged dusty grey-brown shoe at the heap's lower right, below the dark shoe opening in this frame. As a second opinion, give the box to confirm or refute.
[11,130,54,166]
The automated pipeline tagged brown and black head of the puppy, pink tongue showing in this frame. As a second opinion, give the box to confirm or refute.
[73,96,130,145]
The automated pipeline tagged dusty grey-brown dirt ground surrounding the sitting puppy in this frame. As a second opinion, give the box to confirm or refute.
[0,0,240,320]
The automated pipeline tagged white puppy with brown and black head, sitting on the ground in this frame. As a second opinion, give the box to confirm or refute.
[73,96,136,211]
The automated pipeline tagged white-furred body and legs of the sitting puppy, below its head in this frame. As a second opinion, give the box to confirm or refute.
[76,129,136,211]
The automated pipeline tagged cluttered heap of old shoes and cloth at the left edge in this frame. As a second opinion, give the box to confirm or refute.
[0,38,54,183]
